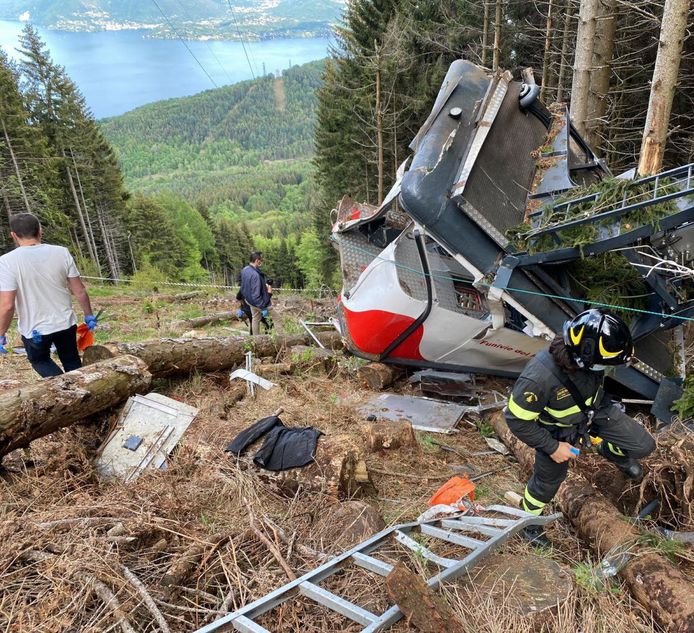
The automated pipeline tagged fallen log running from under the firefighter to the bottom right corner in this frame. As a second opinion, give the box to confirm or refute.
[491,412,694,633]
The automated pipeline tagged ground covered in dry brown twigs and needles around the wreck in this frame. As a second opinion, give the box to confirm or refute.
[0,288,691,633]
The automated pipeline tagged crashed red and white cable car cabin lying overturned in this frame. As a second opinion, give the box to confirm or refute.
[332,60,694,399]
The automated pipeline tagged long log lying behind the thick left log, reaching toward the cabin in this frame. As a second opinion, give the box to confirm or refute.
[84,332,342,378]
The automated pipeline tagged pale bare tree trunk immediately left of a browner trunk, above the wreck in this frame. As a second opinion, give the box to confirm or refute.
[571,0,599,135]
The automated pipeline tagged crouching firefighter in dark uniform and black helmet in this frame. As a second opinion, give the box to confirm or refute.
[504,310,655,546]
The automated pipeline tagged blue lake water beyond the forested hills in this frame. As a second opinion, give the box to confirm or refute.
[0,20,329,118]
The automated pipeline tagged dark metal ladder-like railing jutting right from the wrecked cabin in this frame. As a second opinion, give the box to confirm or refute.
[526,163,694,242]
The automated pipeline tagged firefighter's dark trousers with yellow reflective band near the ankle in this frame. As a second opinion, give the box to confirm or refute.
[523,405,655,514]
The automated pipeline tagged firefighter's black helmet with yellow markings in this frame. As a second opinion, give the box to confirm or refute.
[563,309,634,369]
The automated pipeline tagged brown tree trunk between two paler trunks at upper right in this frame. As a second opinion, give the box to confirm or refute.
[586,0,617,150]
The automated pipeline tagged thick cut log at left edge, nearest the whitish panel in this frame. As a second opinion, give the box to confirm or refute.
[0,356,152,457]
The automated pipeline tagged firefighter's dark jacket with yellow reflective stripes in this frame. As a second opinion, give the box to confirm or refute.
[504,349,609,455]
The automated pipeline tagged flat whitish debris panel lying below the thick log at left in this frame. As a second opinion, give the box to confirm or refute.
[94,393,198,482]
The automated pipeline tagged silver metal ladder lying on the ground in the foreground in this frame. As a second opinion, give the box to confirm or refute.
[196,505,561,633]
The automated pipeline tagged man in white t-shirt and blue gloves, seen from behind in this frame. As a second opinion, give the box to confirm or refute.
[0,213,96,378]
